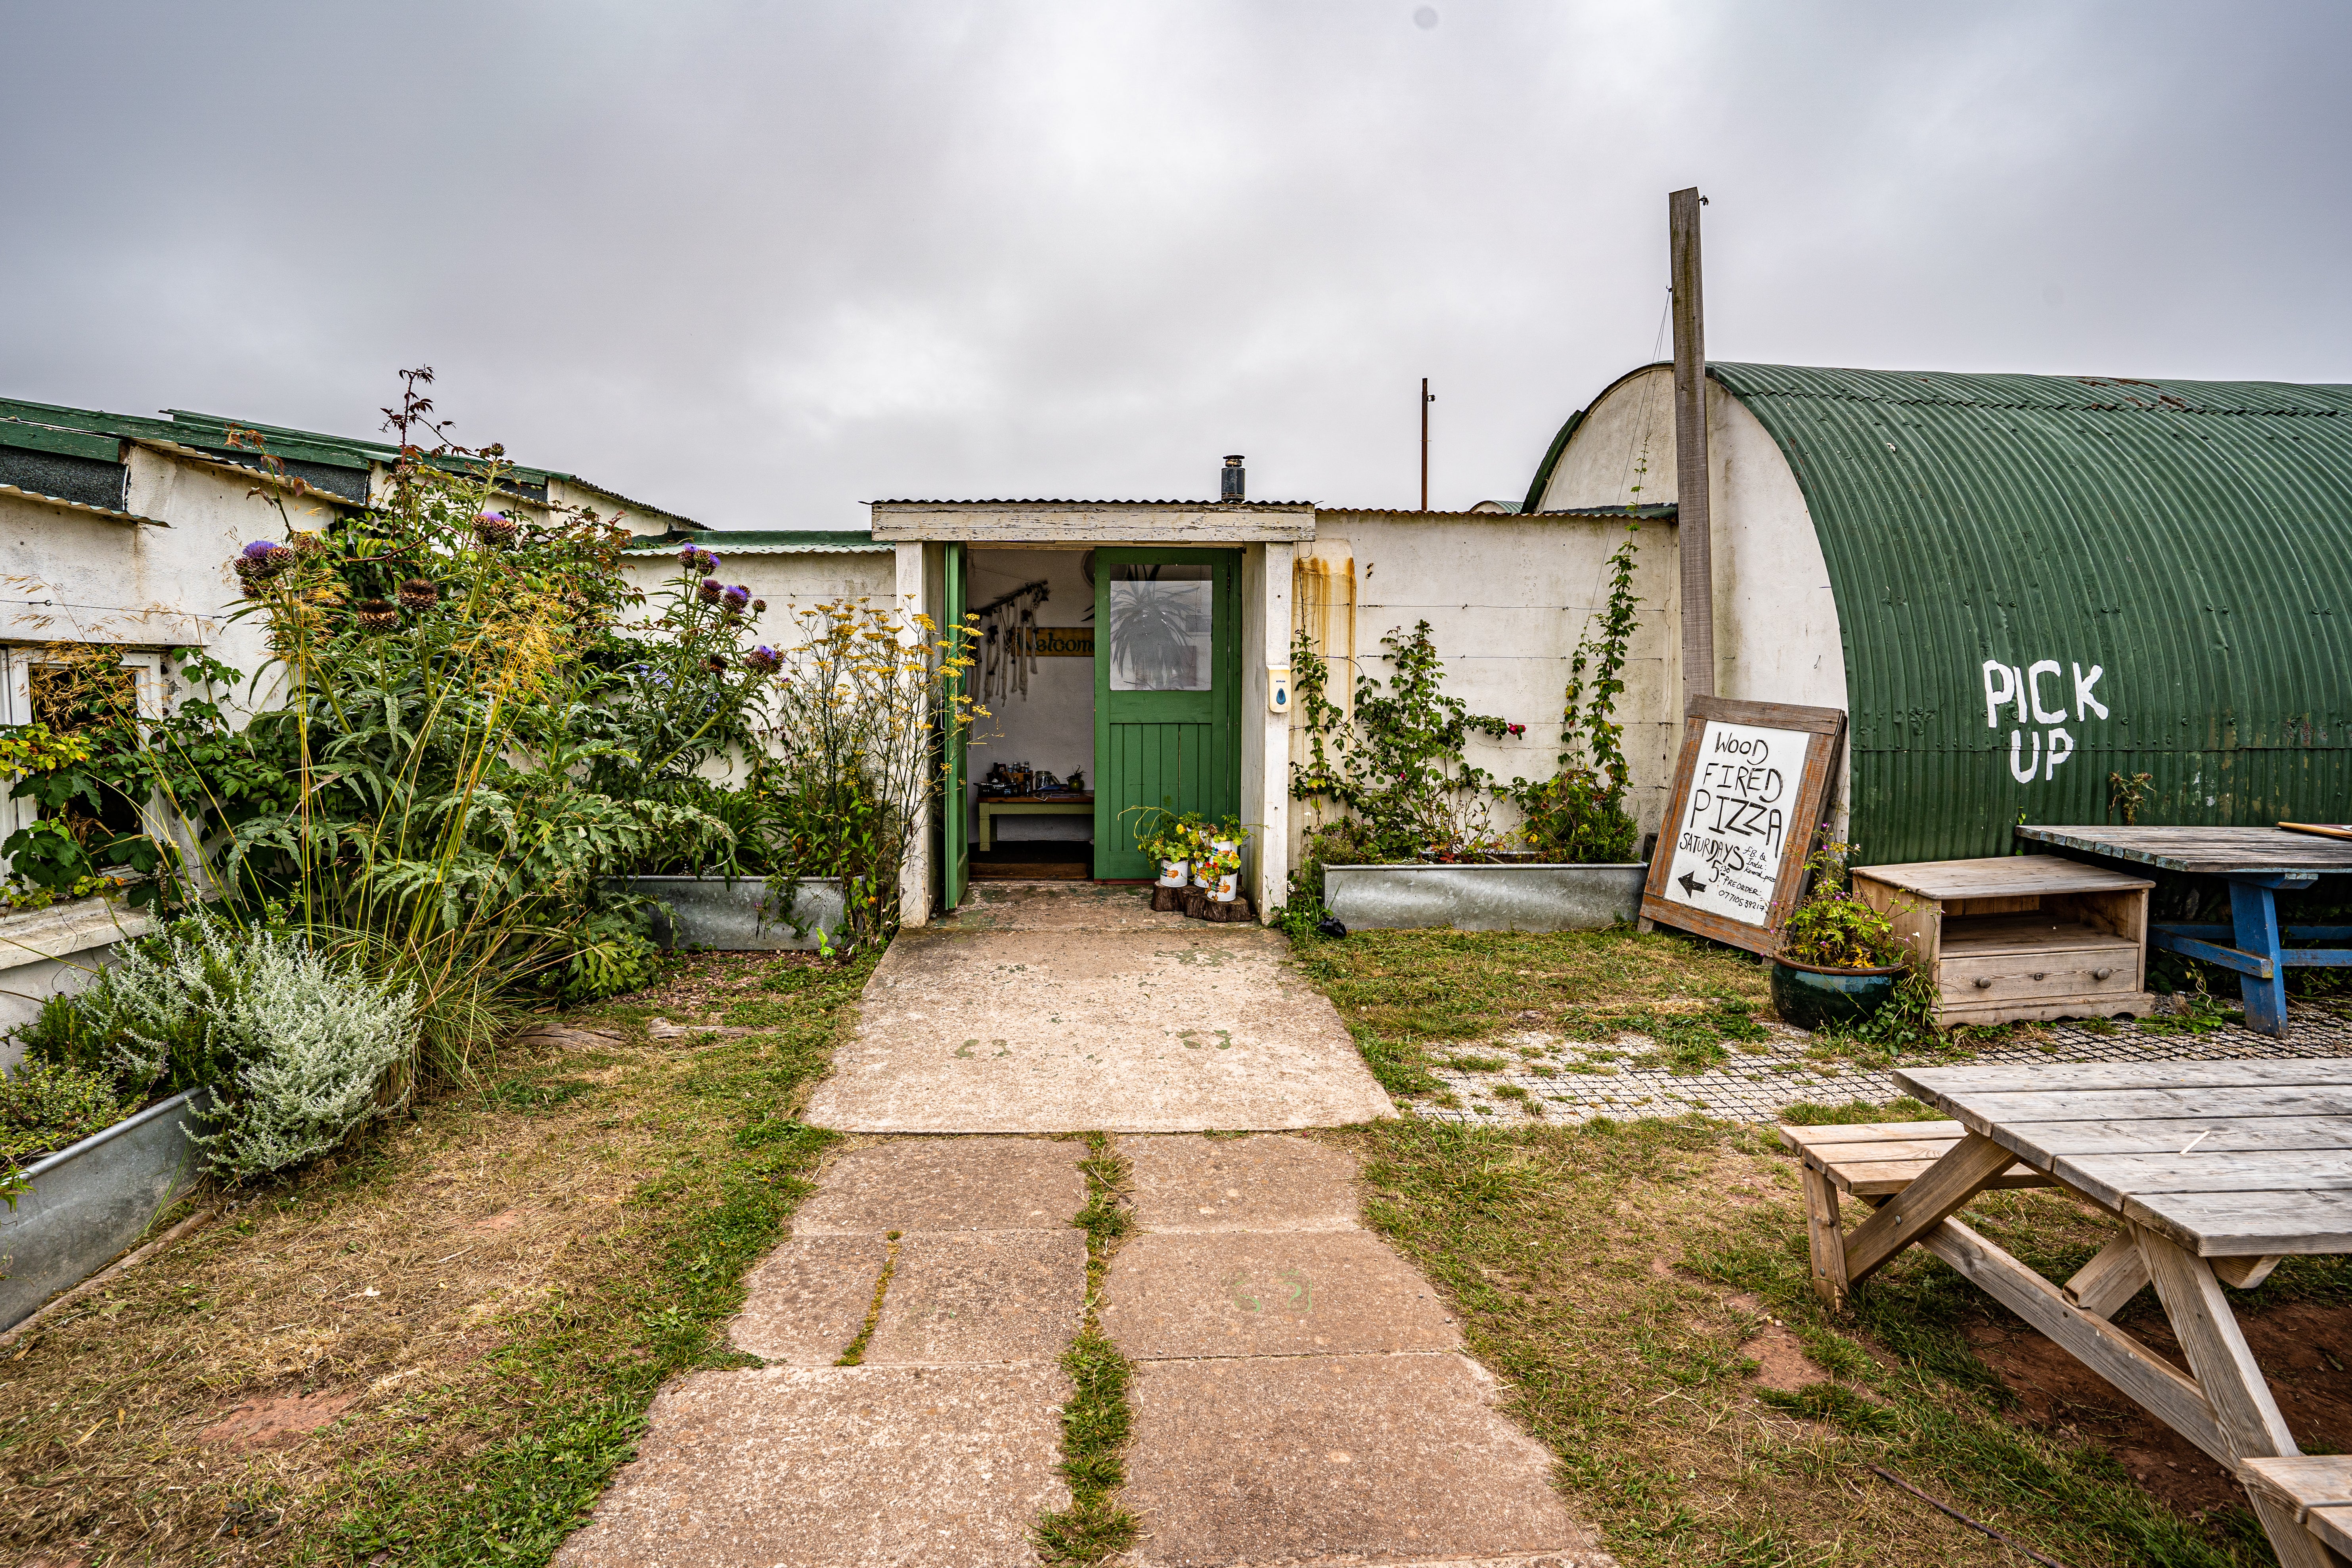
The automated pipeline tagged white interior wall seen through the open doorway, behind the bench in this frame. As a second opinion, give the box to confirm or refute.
[965,550,1096,842]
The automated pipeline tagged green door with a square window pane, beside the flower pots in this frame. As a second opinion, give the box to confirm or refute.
[1094,548,1242,879]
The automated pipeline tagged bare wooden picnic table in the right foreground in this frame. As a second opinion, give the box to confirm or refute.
[1780,1058,2352,1568]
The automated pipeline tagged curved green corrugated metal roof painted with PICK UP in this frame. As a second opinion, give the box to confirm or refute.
[1710,364,2352,863]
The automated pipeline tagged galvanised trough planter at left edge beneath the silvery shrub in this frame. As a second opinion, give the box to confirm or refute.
[0,1088,205,1328]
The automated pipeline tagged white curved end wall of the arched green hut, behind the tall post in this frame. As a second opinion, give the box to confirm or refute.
[1543,364,1846,830]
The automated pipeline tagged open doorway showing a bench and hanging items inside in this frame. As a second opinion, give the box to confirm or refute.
[965,550,1096,882]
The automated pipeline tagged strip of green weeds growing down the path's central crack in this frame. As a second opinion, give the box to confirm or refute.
[1035,1133,1136,1563]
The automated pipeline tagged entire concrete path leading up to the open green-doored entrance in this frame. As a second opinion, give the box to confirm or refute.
[555,884,1609,1568]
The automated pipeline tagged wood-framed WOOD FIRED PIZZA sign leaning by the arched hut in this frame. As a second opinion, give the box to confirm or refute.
[1642,696,1846,952]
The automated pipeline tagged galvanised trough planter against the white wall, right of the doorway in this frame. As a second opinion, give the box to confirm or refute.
[1324,863,1649,931]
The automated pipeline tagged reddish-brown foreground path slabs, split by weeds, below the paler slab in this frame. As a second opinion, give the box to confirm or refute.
[557,1135,1609,1568]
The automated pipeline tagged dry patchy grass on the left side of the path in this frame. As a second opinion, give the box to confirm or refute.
[0,954,870,1568]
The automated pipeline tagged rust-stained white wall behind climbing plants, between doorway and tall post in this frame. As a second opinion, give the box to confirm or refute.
[1291,510,1679,846]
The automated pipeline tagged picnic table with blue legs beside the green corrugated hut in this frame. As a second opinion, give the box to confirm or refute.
[2018,827,2352,1037]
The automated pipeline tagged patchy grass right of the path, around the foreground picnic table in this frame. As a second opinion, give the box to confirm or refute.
[1343,1119,2352,1568]
